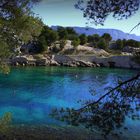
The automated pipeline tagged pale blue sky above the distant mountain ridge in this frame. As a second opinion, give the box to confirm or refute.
[33,0,140,35]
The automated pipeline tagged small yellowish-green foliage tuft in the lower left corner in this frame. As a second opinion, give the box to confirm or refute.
[0,113,12,134]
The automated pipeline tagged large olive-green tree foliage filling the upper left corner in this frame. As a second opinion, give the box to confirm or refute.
[0,0,42,73]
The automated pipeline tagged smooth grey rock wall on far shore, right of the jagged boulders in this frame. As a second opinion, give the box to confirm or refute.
[54,55,140,69]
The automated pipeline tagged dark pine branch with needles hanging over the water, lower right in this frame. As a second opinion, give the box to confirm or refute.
[51,74,140,136]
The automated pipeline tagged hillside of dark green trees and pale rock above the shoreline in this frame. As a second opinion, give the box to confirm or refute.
[20,25,140,55]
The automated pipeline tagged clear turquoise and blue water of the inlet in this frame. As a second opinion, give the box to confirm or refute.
[0,67,140,127]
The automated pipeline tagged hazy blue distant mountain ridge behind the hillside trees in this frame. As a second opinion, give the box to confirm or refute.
[51,26,140,41]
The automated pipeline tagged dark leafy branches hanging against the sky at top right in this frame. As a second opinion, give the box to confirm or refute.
[75,0,140,25]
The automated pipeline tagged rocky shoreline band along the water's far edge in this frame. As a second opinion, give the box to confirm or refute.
[8,55,140,69]
